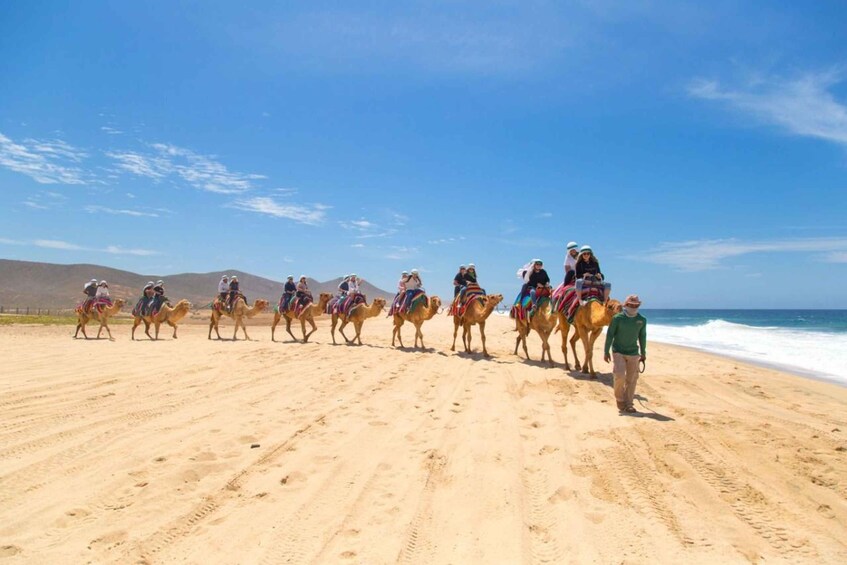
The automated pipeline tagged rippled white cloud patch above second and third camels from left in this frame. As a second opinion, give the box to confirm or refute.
[106,143,266,194]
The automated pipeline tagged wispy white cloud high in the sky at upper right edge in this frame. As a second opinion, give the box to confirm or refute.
[688,71,847,145]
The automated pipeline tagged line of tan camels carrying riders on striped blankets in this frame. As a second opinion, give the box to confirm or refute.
[74,242,643,378]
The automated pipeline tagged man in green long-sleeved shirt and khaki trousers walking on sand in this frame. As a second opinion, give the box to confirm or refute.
[603,294,647,414]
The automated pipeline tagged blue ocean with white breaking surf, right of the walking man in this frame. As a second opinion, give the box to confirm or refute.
[642,308,847,385]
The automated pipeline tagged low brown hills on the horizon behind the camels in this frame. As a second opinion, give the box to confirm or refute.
[0,259,394,309]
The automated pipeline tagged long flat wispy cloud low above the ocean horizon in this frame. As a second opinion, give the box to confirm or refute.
[643,237,847,271]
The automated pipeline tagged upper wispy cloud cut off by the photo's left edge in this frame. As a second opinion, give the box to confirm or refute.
[0,133,90,184]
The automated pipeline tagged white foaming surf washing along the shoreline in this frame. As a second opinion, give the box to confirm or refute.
[647,320,847,384]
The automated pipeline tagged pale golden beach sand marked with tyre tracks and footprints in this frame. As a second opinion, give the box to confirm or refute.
[0,316,847,564]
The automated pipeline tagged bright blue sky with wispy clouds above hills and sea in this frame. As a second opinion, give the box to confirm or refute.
[0,0,847,308]
